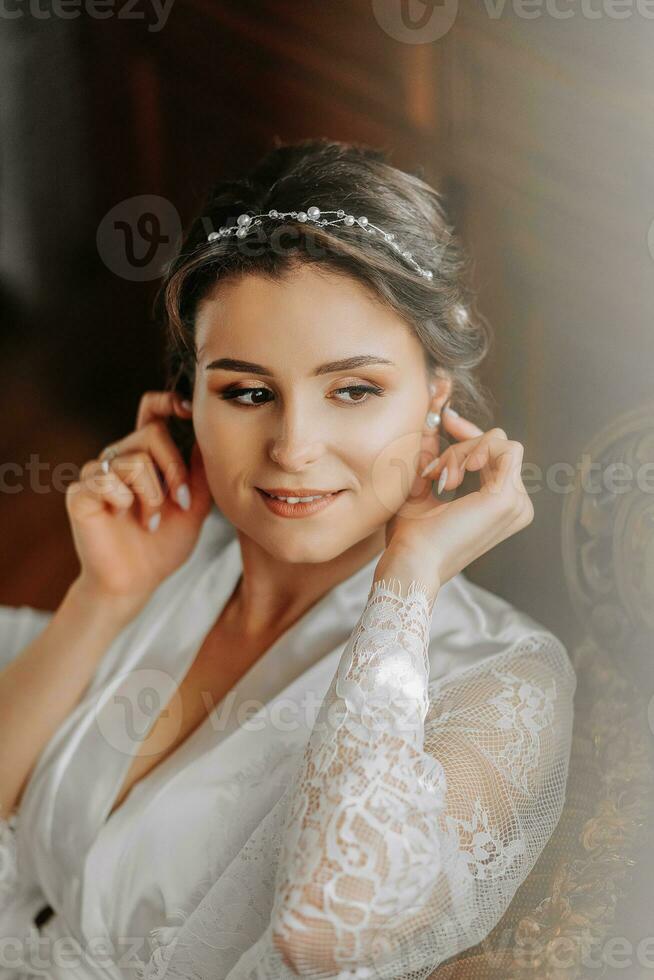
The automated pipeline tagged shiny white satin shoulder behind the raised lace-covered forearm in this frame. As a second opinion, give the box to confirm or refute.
[429,572,574,679]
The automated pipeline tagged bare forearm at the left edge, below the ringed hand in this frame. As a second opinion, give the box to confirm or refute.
[0,579,143,819]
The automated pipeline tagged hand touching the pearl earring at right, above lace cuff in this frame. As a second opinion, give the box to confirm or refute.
[378,411,534,590]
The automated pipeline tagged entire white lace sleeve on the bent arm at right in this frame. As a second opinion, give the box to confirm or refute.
[264,582,576,980]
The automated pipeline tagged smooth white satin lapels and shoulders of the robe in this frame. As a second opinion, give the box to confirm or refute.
[0,508,564,980]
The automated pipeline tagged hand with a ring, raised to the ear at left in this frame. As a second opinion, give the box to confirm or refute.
[66,391,212,612]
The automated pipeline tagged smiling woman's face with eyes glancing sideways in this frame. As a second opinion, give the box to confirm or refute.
[193,265,440,562]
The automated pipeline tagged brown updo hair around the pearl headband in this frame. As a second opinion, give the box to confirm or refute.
[154,139,492,428]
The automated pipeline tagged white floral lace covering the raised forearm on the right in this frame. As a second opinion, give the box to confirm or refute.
[274,583,444,962]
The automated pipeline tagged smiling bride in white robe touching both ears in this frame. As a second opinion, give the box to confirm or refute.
[0,140,575,980]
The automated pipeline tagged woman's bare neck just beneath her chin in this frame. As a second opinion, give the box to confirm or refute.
[225,527,386,639]
